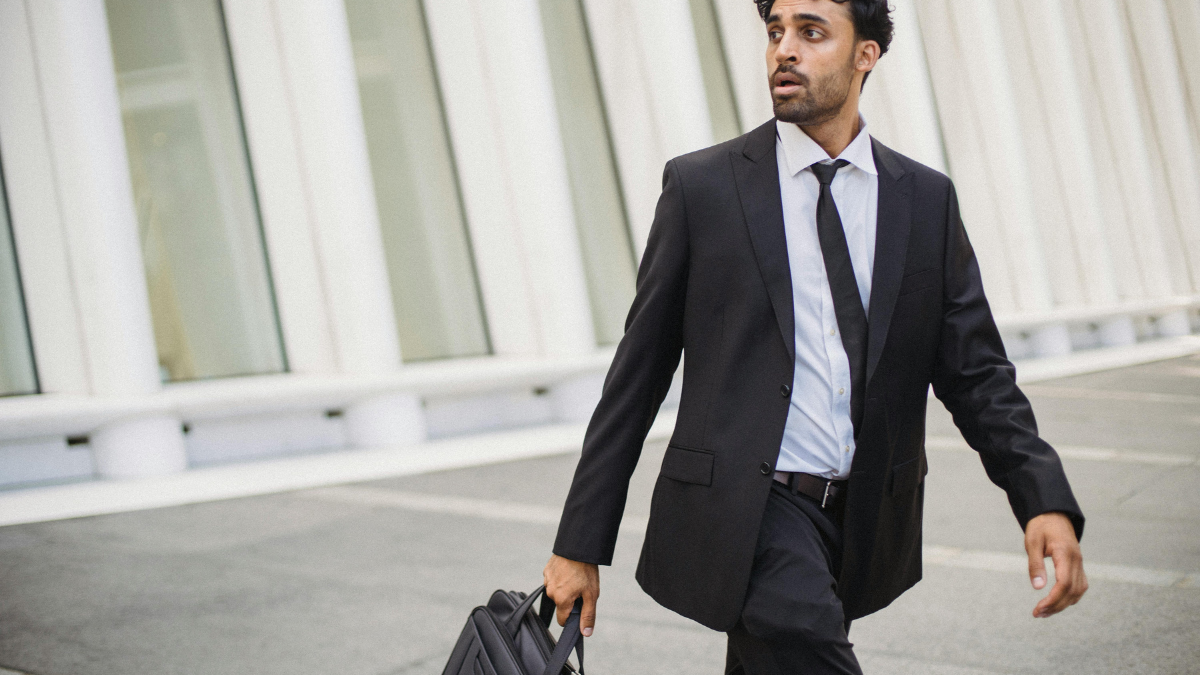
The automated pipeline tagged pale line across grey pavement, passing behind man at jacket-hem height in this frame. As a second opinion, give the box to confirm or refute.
[302,485,1200,589]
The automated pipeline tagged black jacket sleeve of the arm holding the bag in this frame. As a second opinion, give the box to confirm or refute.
[554,161,689,565]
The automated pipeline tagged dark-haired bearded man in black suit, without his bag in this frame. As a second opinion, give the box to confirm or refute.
[545,0,1087,675]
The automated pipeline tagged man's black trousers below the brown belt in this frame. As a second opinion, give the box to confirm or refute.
[725,483,863,675]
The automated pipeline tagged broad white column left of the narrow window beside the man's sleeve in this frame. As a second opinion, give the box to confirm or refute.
[426,0,595,356]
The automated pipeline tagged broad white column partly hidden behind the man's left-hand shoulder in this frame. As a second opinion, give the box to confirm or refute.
[583,0,715,257]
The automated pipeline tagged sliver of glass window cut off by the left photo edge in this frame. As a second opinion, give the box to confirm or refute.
[0,151,37,395]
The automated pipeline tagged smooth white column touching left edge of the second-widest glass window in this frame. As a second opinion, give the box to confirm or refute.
[271,0,400,375]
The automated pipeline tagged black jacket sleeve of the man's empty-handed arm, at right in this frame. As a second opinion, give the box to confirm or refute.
[932,180,1084,537]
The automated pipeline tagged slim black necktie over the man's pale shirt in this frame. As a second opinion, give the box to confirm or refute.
[811,160,866,436]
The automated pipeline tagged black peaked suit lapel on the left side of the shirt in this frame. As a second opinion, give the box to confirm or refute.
[730,120,796,362]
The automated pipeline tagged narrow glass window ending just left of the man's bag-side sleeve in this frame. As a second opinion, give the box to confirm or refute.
[540,0,636,345]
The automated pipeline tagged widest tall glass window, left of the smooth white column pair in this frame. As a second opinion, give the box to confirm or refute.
[106,0,287,381]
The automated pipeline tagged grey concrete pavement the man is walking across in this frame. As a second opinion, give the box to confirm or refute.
[0,357,1200,675]
